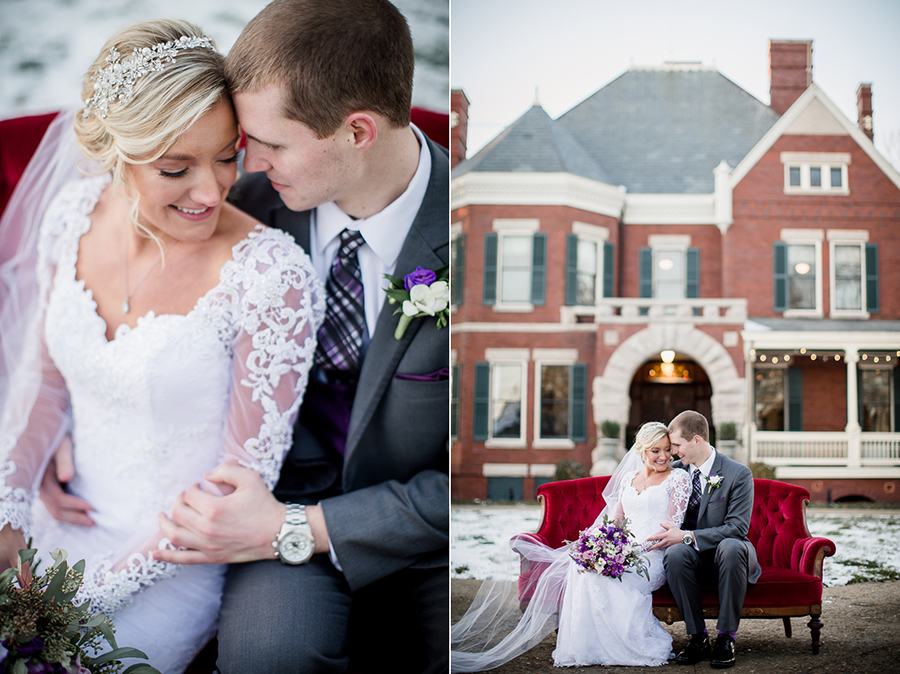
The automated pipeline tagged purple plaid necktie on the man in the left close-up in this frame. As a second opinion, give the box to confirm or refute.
[315,229,368,379]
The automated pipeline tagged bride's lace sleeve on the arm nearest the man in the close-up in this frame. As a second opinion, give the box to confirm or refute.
[81,230,325,614]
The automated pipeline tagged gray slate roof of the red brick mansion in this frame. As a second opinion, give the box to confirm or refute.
[453,68,778,194]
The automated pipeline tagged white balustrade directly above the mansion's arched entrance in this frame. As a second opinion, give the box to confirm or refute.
[560,297,747,325]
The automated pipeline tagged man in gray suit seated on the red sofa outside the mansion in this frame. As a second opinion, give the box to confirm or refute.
[650,410,761,669]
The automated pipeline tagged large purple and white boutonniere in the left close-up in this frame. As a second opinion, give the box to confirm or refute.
[384,265,450,339]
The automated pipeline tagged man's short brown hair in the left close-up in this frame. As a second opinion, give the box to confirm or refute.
[225,0,415,138]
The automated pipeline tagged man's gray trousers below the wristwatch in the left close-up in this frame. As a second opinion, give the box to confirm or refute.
[217,554,450,674]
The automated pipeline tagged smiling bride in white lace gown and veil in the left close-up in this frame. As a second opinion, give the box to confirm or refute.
[0,21,324,672]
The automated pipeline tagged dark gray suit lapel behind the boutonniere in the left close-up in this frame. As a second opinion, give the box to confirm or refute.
[344,141,450,466]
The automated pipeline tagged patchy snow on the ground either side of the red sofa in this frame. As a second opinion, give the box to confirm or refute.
[450,504,900,587]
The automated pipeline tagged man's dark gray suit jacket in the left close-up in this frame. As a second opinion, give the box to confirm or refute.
[231,141,450,590]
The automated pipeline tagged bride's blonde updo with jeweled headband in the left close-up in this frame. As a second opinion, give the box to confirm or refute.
[74,19,227,245]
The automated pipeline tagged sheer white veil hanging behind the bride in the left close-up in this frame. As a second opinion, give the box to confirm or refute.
[0,110,84,461]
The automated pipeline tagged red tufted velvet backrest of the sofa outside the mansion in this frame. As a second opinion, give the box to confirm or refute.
[538,476,809,569]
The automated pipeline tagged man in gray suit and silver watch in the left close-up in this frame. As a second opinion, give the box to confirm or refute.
[158,0,449,674]
